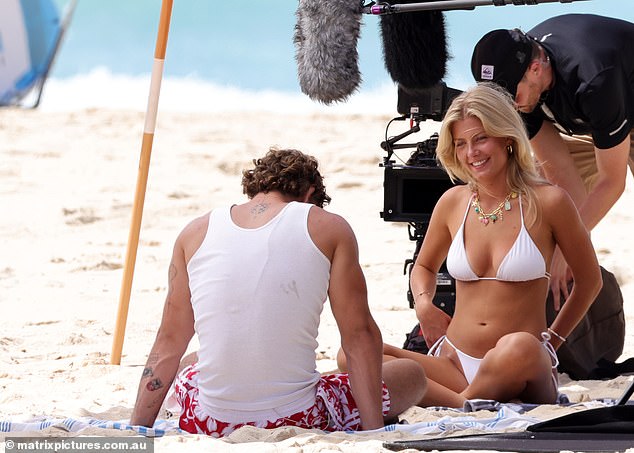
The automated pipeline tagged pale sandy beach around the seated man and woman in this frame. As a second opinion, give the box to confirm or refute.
[0,109,634,452]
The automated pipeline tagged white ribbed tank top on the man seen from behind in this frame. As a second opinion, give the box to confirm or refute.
[187,202,330,423]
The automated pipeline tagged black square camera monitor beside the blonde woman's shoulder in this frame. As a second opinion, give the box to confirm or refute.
[381,166,453,223]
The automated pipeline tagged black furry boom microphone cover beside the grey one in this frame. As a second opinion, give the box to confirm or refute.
[381,0,448,91]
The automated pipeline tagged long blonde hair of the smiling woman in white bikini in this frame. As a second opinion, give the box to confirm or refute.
[436,82,547,224]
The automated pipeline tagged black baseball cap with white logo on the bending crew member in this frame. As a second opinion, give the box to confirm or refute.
[471,28,533,96]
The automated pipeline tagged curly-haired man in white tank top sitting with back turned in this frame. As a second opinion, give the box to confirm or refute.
[130,149,426,437]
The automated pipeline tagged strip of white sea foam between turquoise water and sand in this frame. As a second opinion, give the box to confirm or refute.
[40,67,397,115]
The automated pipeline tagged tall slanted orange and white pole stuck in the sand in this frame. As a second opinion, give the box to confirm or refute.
[110,0,172,365]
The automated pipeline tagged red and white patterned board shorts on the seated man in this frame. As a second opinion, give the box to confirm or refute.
[174,365,390,437]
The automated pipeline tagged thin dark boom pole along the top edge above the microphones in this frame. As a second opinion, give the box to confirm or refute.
[363,0,589,16]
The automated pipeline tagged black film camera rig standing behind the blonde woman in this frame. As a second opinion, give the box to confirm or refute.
[381,82,461,316]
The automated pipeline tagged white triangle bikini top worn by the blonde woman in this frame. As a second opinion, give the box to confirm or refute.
[447,195,550,282]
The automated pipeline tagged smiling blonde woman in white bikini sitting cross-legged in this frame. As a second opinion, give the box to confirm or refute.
[338,84,602,407]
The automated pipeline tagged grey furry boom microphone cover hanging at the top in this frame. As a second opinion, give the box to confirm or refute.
[293,0,362,104]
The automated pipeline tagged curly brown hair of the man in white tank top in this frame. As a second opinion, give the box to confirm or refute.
[242,147,330,208]
